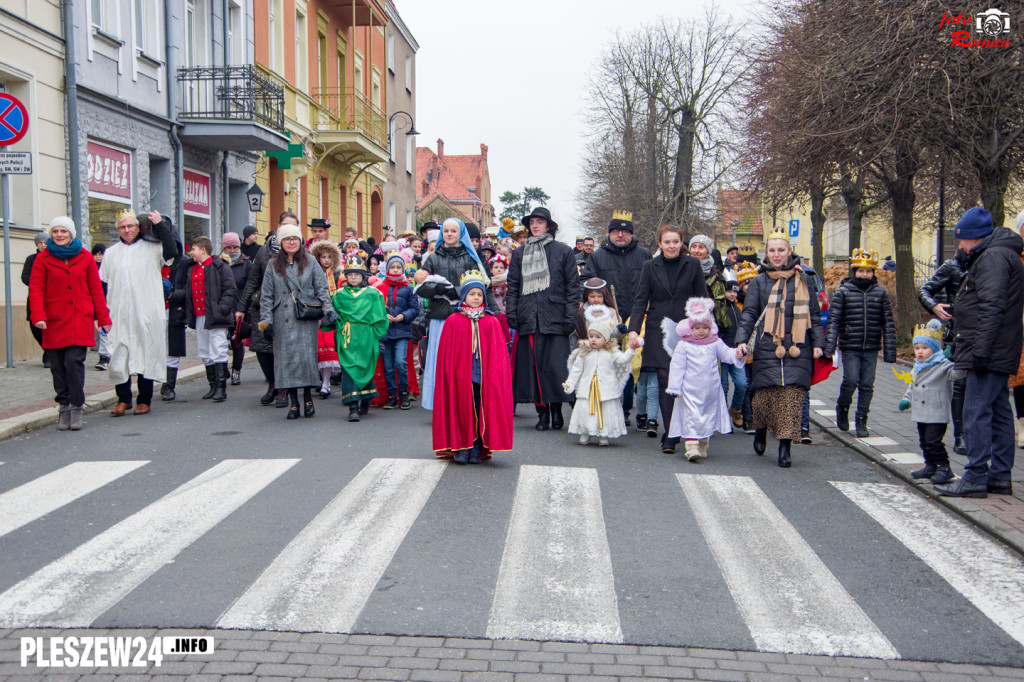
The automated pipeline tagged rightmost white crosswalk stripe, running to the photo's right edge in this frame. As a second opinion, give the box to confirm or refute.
[830,481,1024,644]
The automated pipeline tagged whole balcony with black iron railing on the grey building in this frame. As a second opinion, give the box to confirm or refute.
[178,65,288,152]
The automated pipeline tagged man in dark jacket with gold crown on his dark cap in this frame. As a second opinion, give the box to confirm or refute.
[581,211,650,426]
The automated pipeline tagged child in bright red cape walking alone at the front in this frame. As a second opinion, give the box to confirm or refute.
[433,270,513,464]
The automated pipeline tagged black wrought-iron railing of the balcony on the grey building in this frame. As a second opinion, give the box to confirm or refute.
[178,65,285,132]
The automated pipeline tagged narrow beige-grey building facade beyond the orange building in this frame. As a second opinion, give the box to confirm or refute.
[385,0,420,235]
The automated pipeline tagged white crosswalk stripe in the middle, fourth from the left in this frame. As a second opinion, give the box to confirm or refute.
[487,465,623,642]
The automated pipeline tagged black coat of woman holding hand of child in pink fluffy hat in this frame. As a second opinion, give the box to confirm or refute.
[629,254,708,370]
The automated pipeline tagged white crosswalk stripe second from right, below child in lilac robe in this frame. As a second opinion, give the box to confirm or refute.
[676,474,899,658]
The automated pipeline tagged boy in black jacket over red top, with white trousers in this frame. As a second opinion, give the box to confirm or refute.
[184,237,239,402]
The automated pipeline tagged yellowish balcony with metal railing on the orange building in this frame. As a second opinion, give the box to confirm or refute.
[309,88,390,163]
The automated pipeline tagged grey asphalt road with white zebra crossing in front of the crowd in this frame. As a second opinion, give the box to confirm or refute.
[0,368,1024,667]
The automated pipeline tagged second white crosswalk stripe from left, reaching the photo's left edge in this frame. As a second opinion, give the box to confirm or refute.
[0,459,299,628]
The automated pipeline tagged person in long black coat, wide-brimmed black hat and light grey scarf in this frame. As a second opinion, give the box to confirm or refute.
[505,207,582,431]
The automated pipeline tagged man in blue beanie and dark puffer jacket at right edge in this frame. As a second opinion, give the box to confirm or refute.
[935,207,1024,498]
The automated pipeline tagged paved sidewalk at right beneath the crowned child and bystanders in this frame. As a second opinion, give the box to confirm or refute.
[811,361,1024,553]
